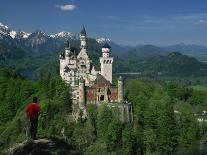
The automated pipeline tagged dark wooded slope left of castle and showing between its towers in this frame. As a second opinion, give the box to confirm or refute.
[0,38,106,80]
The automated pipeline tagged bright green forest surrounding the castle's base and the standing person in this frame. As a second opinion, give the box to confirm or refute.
[0,66,207,155]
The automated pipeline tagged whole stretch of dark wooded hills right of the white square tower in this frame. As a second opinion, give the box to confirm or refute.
[114,52,207,77]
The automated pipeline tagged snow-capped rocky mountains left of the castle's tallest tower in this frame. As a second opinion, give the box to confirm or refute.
[0,23,74,53]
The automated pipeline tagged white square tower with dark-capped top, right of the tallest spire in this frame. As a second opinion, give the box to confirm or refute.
[100,43,113,83]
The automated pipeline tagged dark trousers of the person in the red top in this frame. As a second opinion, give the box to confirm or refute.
[30,116,38,140]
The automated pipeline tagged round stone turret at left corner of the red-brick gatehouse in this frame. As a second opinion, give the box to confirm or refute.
[79,77,86,109]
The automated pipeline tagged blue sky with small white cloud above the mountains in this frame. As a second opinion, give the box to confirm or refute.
[0,0,207,46]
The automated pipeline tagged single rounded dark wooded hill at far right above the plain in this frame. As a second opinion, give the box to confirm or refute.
[143,52,207,76]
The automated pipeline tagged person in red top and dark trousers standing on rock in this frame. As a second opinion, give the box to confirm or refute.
[26,97,40,140]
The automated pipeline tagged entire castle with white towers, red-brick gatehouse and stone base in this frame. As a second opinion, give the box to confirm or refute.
[59,27,132,121]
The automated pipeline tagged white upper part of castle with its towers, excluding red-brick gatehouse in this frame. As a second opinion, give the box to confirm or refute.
[60,27,113,87]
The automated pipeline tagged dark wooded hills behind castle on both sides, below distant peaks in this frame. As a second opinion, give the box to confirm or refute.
[0,38,207,80]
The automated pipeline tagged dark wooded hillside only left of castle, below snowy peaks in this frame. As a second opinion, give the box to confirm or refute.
[0,42,58,79]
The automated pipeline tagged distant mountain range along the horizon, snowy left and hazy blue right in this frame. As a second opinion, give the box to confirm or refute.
[0,23,207,61]
